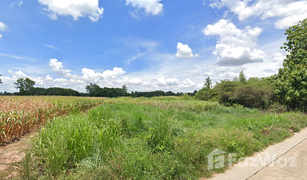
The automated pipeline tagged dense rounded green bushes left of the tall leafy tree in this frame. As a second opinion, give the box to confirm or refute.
[195,74,279,110]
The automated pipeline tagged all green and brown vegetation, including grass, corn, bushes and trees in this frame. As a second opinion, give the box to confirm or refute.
[0,16,307,180]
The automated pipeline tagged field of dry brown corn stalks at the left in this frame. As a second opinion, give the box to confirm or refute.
[0,96,103,145]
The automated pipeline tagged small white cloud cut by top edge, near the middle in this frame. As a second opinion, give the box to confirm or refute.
[126,0,163,16]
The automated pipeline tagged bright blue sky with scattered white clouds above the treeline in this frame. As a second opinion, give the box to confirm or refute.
[0,0,307,92]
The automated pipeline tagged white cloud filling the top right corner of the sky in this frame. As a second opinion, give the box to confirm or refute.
[210,0,307,29]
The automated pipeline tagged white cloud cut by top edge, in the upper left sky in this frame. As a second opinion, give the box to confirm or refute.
[38,0,103,22]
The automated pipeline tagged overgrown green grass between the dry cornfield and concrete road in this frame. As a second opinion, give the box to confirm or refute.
[21,97,307,179]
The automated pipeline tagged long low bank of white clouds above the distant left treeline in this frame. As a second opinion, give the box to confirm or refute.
[0,59,203,92]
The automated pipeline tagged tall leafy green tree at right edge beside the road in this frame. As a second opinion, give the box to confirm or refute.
[270,19,307,111]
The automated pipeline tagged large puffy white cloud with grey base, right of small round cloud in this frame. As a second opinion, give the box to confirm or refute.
[203,19,265,66]
